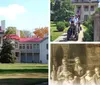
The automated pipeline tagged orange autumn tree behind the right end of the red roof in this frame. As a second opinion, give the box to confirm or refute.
[33,27,48,38]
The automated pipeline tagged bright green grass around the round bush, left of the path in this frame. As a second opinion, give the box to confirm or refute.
[50,22,68,41]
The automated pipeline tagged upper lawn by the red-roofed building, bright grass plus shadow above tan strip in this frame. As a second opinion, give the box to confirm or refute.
[0,64,48,74]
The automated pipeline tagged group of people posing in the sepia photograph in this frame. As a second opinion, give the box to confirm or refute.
[50,57,100,85]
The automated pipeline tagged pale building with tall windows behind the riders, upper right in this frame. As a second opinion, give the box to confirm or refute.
[72,0,98,21]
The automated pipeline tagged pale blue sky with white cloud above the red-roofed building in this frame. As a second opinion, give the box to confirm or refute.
[0,0,49,32]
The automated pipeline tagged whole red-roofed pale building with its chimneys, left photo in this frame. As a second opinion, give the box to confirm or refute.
[0,21,48,64]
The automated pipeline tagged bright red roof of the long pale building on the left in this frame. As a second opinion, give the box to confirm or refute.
[4,34,43,42]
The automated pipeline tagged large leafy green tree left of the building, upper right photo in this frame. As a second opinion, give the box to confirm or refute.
[51,0,74,21]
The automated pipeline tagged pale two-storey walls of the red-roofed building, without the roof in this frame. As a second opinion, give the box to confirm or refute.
[13,38,48,64]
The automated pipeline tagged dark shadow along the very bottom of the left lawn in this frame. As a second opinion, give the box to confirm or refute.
[0,78,48,85]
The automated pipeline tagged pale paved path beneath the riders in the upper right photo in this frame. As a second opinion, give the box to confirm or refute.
[54,26,84,42]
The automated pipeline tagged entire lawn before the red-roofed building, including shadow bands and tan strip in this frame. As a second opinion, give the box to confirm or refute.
[0,63,48,85]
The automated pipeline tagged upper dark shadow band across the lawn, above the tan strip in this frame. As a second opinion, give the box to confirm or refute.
[0,68,48,74]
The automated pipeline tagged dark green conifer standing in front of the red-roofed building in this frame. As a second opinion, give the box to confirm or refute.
[0,39,16,63]
